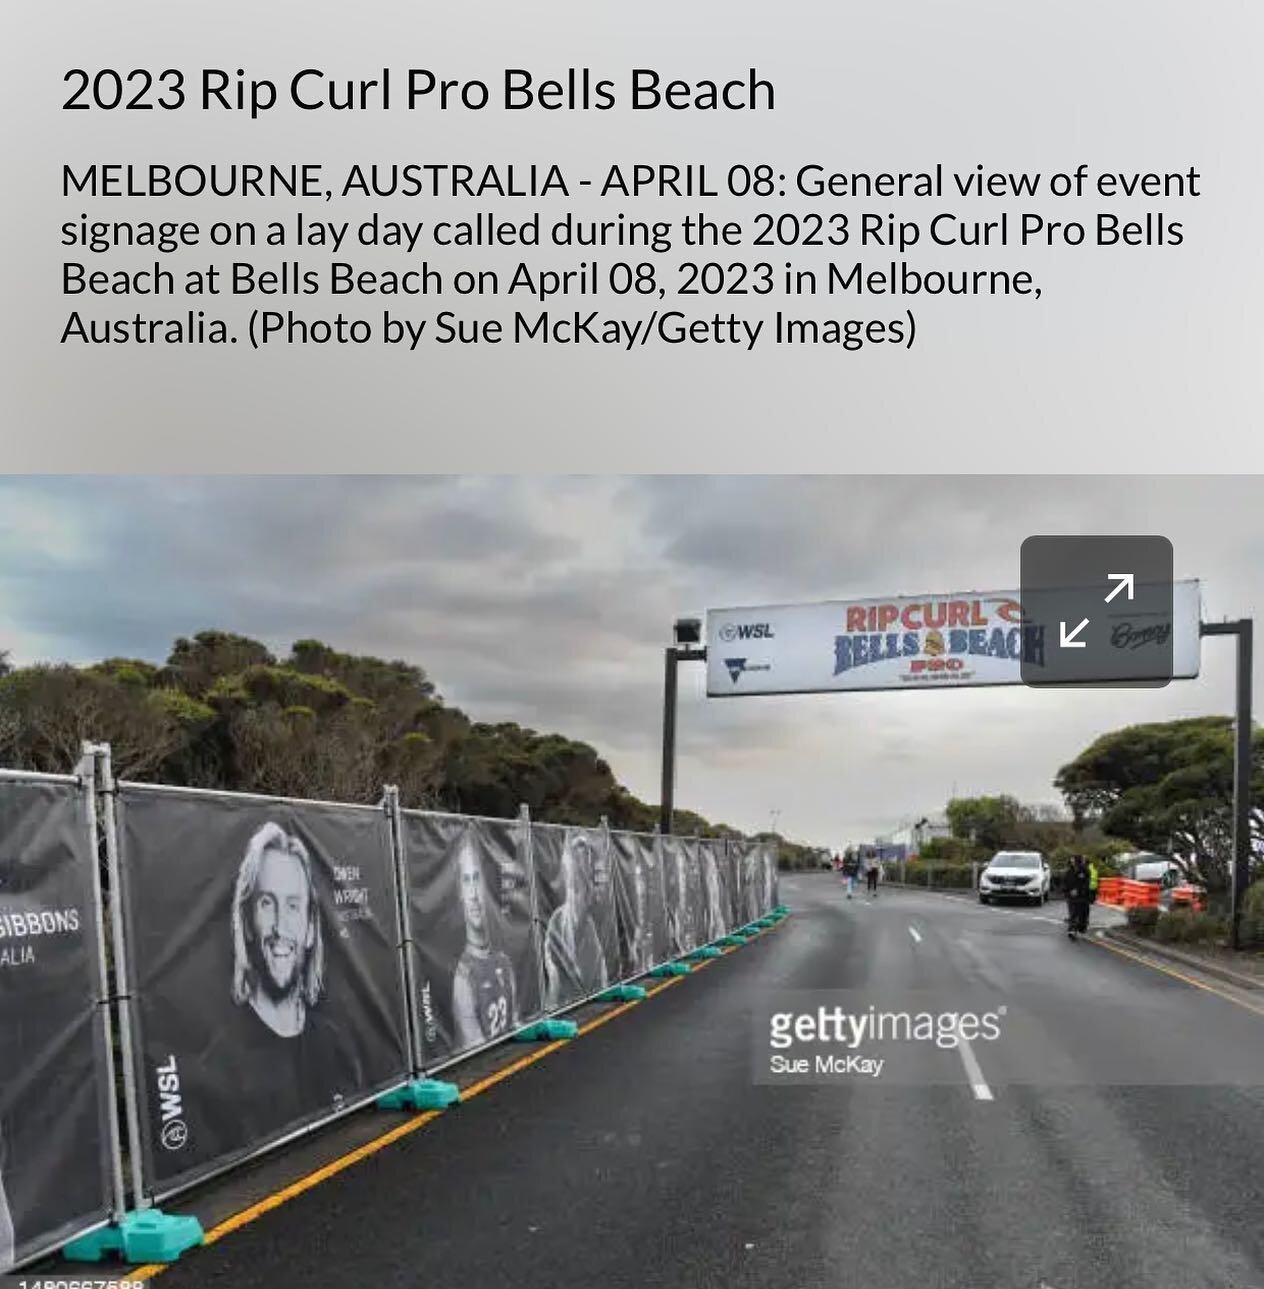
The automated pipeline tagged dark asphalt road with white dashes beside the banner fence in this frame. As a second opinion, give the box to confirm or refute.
[158,875,1264,1289]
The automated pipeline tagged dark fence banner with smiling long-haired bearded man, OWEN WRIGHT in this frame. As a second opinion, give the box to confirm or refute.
[119,784,410,1194]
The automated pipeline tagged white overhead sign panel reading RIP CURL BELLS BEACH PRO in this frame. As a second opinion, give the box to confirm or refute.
[706,581,1201,697]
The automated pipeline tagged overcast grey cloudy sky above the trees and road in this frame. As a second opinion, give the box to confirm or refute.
[0,476,1264,846]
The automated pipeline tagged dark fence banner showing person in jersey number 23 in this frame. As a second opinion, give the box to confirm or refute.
[402,811,541,1067]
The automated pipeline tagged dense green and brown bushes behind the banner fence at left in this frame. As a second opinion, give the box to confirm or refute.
[0,630,816,867]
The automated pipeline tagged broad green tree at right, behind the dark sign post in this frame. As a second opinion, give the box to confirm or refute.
[1054,717,1264,895]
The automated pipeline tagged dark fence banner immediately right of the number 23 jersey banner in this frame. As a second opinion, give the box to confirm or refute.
[531,824,618,1012]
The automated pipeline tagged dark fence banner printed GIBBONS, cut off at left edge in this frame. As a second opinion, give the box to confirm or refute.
[0,777,112,1270]
